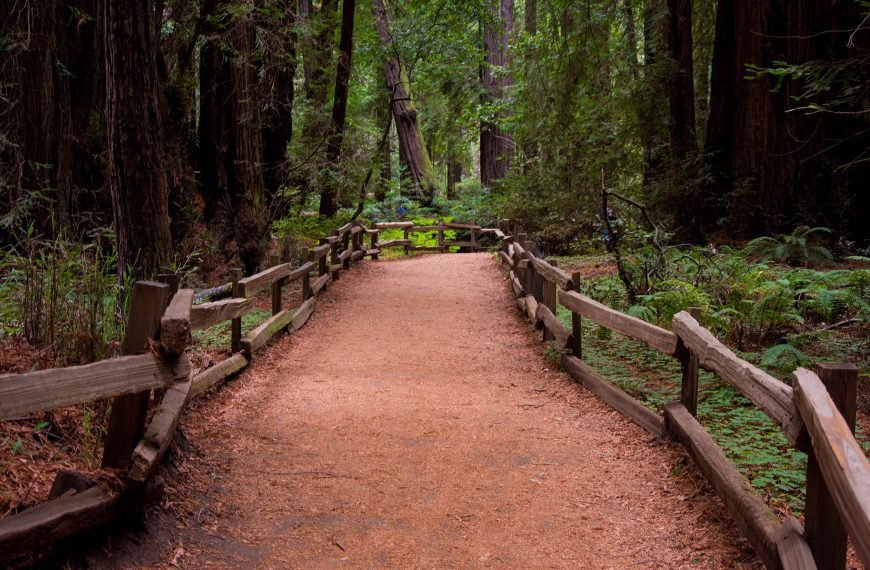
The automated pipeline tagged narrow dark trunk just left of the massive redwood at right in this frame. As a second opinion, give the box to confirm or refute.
[666,0,698,159]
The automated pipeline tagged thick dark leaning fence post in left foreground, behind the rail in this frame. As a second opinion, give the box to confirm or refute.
[102,281,171,469]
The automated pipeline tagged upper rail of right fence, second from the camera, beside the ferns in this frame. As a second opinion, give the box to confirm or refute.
[672,311,803,445]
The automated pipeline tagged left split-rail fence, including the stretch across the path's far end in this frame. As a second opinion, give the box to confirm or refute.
[0,216,490,566]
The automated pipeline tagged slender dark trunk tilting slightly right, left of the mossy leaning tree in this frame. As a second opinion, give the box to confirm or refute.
[320,0,356,218]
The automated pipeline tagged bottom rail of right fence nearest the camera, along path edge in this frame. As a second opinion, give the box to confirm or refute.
[665,402,781,568]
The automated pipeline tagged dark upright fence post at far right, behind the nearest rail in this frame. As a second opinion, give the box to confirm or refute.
[804,362,858,570]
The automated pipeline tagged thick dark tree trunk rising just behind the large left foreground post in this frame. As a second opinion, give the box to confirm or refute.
[105,0,172,280]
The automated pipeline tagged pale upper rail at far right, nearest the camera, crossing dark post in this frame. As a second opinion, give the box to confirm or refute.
[792,368,870,566]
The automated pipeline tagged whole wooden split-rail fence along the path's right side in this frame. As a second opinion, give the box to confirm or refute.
[498,220,870,569]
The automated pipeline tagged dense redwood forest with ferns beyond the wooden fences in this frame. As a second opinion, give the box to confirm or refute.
[0,0,870,511]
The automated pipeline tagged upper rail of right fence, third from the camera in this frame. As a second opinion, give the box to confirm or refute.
[559,291,677,356]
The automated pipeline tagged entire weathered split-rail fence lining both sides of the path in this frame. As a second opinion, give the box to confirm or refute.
[0,215,870,568]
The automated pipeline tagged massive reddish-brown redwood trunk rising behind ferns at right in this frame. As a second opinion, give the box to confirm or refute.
[706,1,797,235]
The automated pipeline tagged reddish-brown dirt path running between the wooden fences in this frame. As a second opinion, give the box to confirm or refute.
[90,254,754,568]
